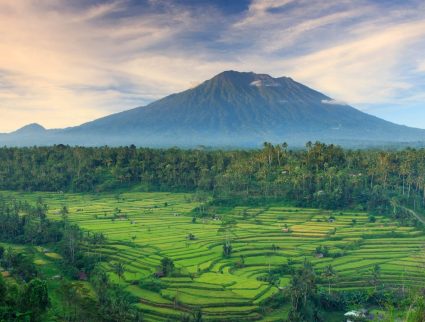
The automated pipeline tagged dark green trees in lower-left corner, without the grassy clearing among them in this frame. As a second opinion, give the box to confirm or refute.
[0,196,141,322]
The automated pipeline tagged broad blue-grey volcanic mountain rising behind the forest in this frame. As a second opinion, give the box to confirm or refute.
[0,71,425,147]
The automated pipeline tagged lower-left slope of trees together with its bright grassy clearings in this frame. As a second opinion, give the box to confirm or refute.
[0,197,141,321]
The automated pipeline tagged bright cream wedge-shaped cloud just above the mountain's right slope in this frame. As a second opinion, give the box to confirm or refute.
[286,21,425,104]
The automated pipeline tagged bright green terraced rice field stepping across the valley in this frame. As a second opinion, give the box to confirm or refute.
[3,193,425,321]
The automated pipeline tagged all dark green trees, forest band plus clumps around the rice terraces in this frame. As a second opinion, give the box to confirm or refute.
[0,143,425,321]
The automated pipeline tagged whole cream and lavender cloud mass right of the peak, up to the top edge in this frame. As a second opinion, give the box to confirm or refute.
[220,0,425,106]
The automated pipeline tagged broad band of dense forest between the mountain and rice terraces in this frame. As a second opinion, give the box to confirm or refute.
[0,142,425,218]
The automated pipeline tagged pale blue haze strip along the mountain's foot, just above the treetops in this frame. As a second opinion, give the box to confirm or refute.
[0,130,425,149]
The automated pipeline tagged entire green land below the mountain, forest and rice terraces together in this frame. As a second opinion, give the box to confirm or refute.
[0,143,425,322]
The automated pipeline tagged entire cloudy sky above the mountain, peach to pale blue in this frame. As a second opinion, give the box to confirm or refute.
[0,0,425,132]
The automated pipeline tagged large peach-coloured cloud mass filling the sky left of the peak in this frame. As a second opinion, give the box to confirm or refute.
[0,0,219,131]
